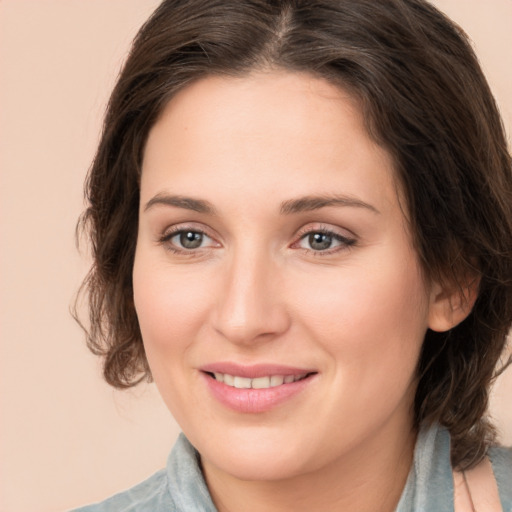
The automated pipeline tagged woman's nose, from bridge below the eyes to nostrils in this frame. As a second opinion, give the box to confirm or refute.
[213,247,290,344]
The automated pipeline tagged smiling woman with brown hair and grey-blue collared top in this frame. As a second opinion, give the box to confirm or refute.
[74,0,512,512]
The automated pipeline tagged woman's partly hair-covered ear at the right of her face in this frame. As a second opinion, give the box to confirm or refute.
[428,276,480,332]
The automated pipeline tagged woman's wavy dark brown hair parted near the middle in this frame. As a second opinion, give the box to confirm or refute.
[76,0,512,469]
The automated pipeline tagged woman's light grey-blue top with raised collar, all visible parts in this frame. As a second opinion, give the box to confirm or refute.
[74,426,512,512]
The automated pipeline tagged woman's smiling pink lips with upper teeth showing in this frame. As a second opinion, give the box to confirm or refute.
[201,363,317,414]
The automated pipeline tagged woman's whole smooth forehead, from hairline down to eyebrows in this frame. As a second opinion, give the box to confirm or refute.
[141,71,402,216]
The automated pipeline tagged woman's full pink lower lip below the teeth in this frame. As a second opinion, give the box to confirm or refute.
[203,373,315,414]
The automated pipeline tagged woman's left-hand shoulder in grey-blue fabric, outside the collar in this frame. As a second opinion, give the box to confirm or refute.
[72,469,175,512]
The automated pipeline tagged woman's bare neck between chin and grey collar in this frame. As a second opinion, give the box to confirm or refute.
[203,425,416,512]
